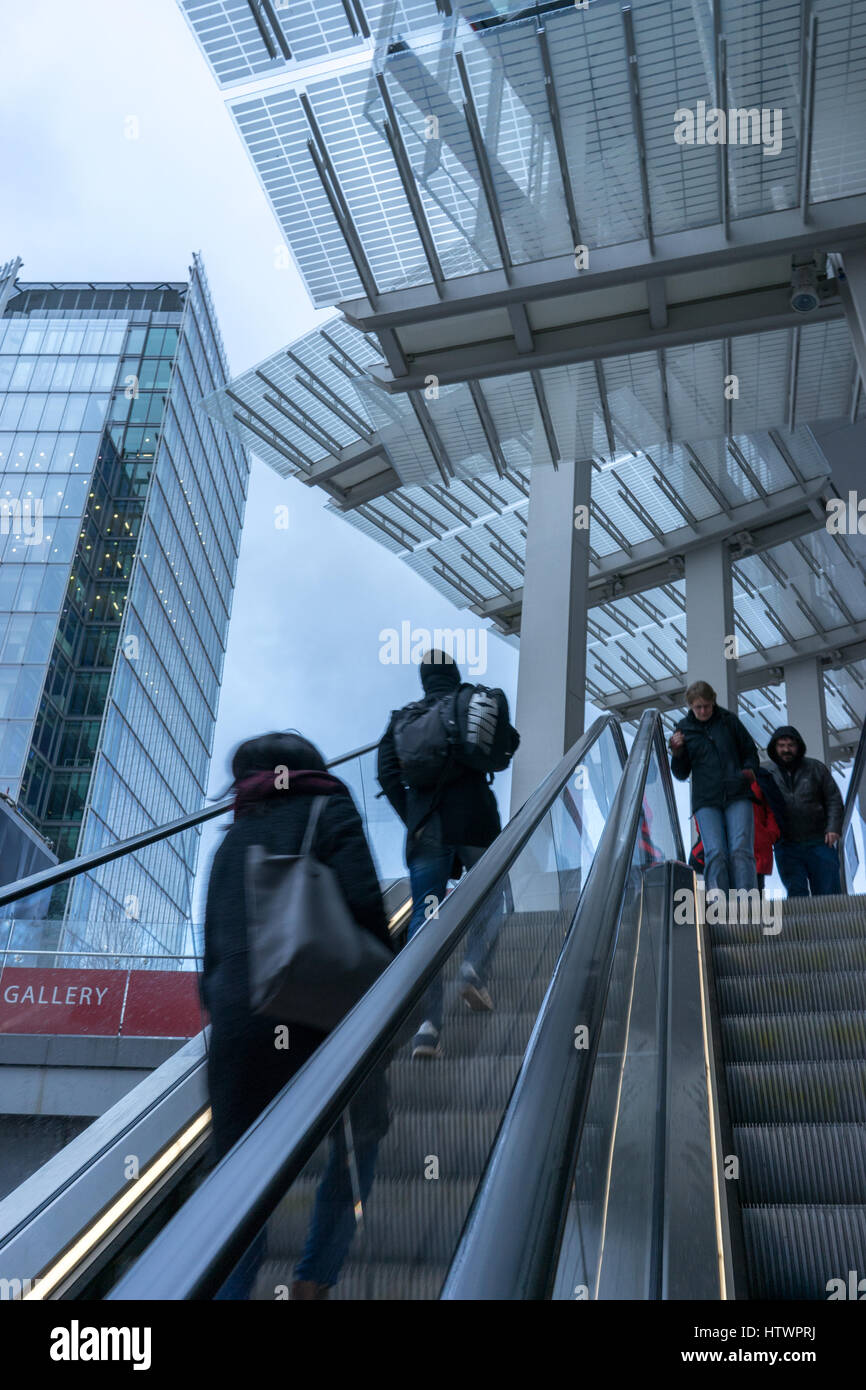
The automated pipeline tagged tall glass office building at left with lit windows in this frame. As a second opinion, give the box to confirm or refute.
[0,257,249,954]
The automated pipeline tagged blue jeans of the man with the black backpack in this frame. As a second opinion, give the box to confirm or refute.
[407,837,502,1031]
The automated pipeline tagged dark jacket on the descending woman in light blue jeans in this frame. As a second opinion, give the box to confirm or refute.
[670,705,760,816]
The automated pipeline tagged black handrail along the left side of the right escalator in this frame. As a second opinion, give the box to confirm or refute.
[441,710,683,1300]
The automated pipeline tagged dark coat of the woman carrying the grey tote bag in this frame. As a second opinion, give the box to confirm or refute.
[202,792,392,1158]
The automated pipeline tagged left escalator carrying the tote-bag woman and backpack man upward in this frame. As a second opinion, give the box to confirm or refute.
[0,719,626,1300]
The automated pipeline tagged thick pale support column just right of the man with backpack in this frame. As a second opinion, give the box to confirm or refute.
[512,453,592,813]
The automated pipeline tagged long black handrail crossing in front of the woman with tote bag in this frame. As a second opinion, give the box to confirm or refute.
[107,714,626,1301]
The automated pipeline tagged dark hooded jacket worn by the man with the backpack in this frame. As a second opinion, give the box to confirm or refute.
[378,663,502,858]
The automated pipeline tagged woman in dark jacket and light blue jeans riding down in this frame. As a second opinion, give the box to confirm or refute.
[669,681,760,894]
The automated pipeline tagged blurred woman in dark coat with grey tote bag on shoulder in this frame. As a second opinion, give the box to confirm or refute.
[202,733,393,1300]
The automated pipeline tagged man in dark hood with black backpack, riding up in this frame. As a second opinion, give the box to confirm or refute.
[378,651,520,1058]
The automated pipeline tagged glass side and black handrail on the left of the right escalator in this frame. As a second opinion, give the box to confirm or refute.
[442,712,697,1301]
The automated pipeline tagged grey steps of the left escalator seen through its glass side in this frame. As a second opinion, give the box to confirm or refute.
[252,912,562,1300]
